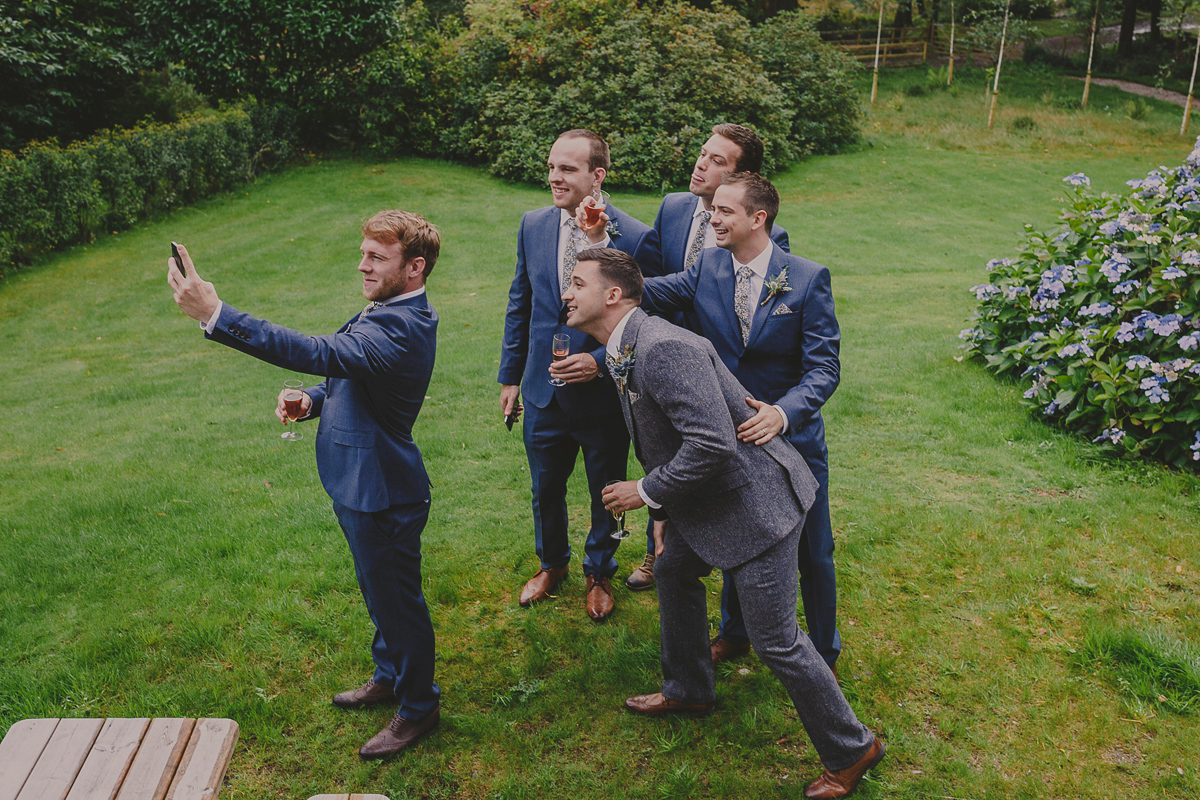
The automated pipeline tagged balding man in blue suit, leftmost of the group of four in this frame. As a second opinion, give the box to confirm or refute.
[498,130,648,621]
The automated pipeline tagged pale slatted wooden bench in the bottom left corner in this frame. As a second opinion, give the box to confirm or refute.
[0,718,238,800]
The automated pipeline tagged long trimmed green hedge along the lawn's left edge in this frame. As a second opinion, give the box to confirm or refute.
[0,102,294,276]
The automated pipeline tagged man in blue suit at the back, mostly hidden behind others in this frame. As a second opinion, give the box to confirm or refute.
[625,122,788,592]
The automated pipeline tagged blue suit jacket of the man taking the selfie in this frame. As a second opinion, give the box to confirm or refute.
[209,294,438,511]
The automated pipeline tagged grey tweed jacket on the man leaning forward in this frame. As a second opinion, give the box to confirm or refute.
[620,309,817,570]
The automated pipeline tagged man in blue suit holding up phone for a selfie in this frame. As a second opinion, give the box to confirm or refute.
[167,211,440,758]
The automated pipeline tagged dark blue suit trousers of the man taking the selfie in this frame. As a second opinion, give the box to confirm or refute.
[334,500,442,721]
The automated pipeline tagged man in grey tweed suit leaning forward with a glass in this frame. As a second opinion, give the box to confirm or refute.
[563,248,884,798]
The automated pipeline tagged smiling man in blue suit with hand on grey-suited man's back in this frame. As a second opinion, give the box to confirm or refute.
[643,173,841,674]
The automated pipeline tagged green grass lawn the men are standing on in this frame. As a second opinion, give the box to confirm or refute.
[0,71,1200,800]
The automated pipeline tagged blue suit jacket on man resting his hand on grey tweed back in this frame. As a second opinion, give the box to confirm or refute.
[642,245,841,459]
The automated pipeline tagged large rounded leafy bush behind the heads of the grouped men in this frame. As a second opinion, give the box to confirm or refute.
[405,0,859,190]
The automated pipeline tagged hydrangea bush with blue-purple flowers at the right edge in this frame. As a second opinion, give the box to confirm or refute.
[959,139,1200,469]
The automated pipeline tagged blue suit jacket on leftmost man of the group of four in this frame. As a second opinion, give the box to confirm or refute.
[498,205,650,416]
